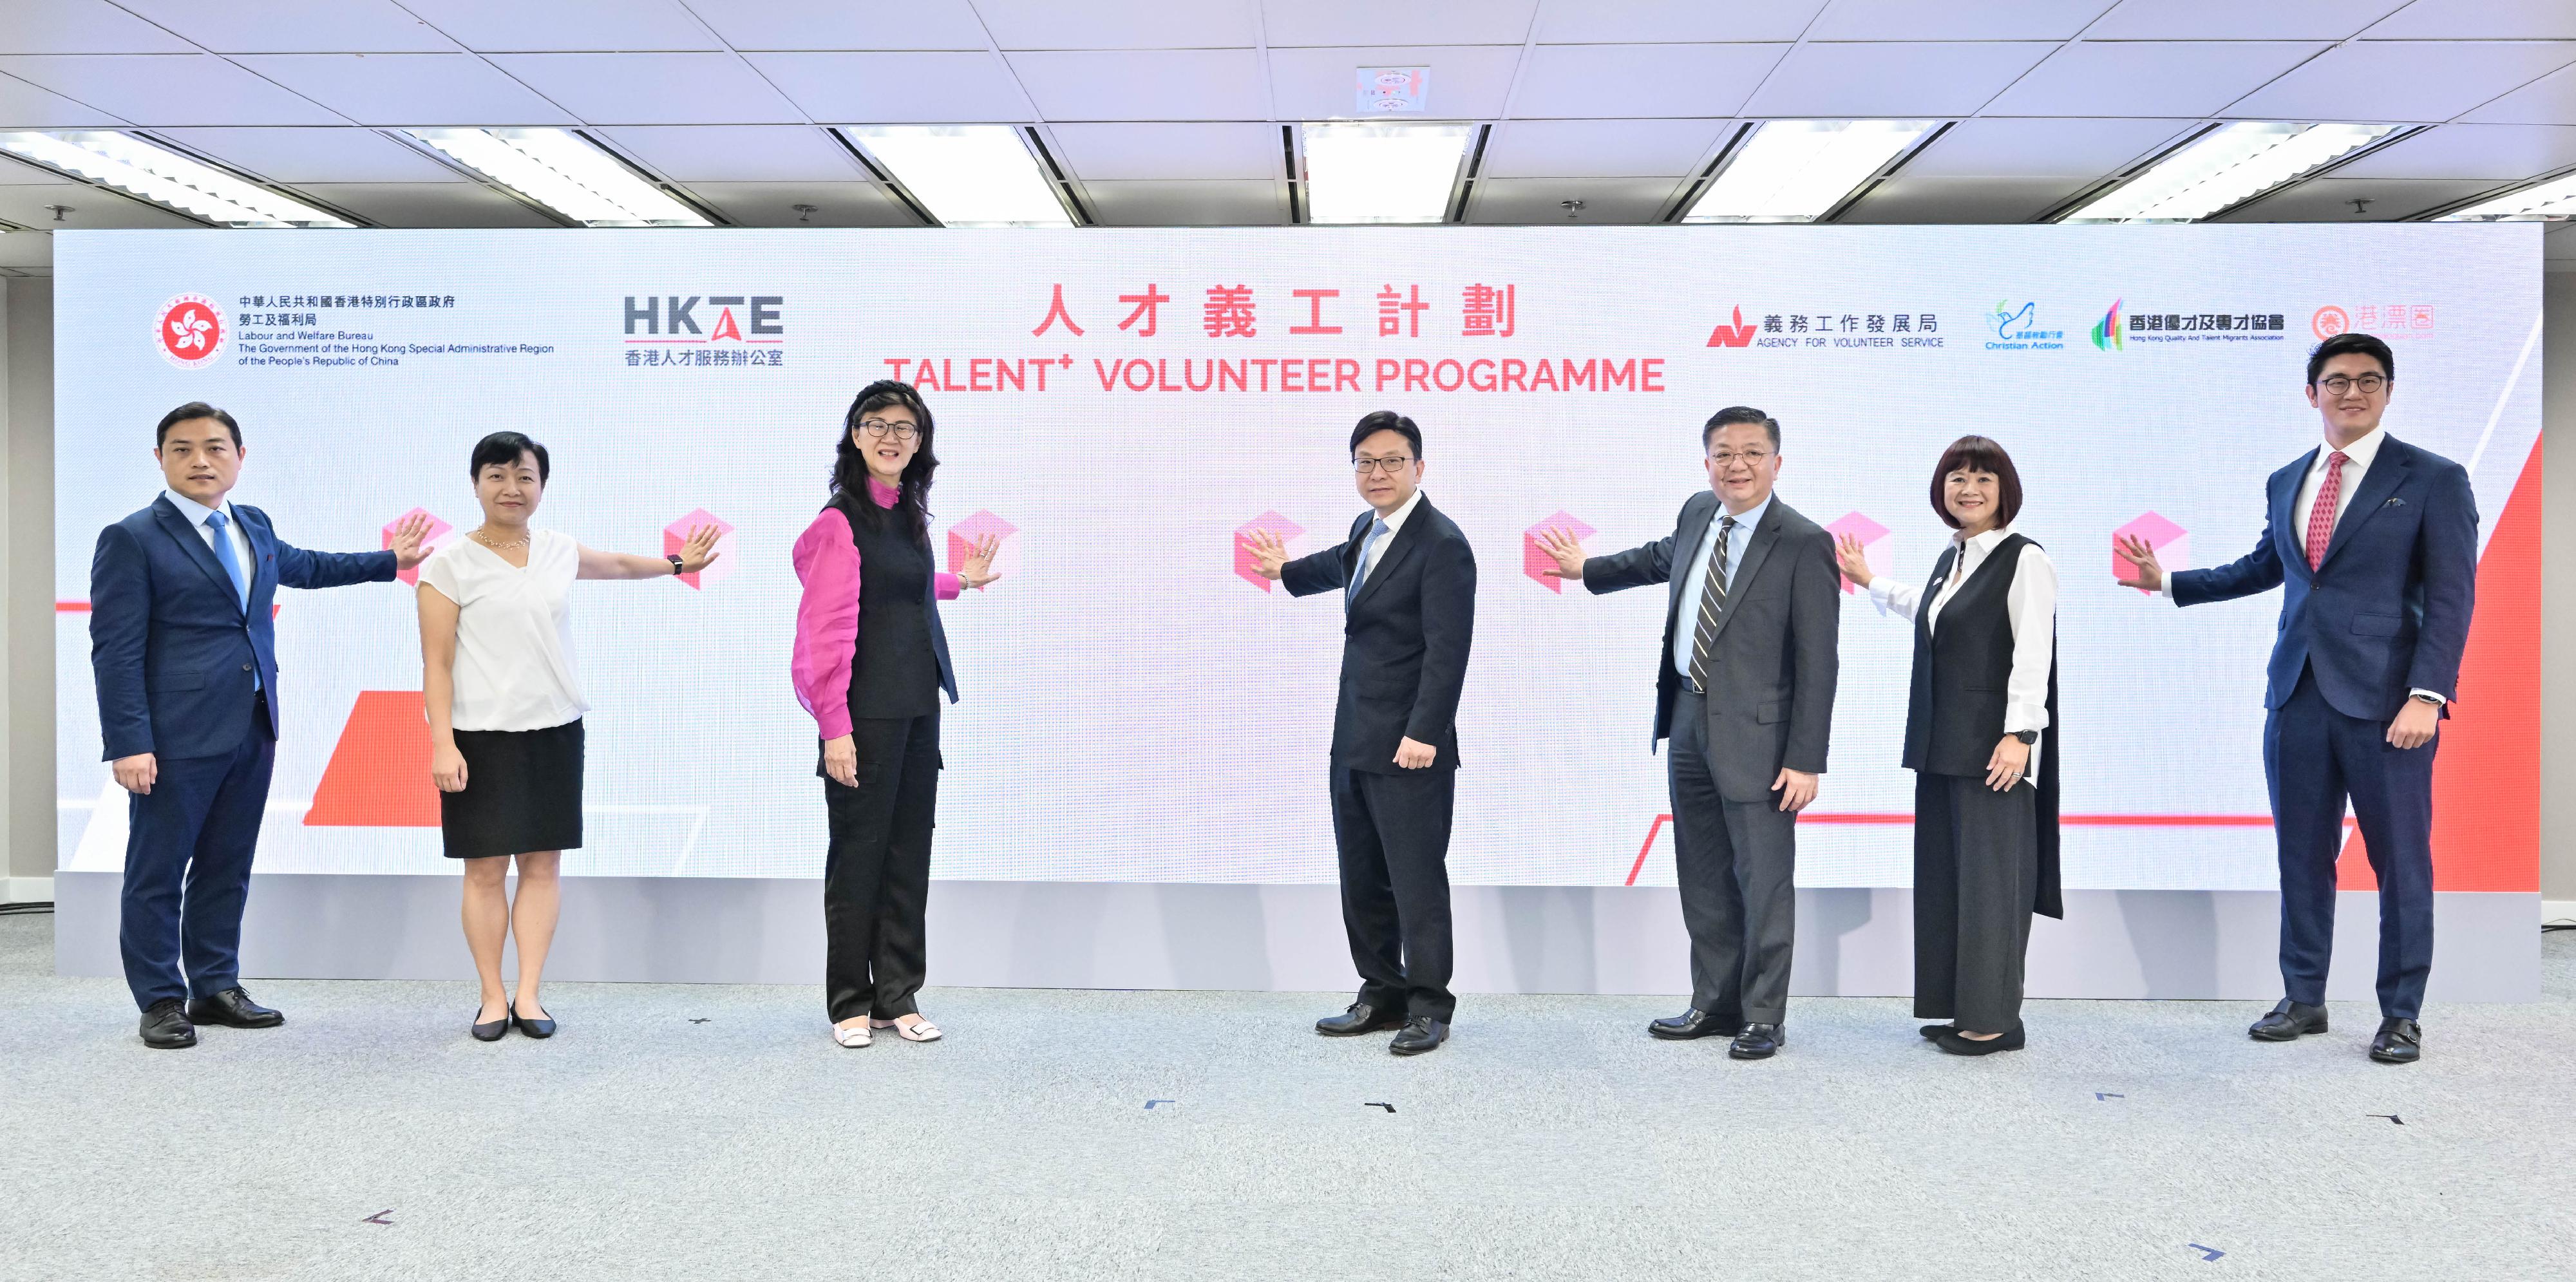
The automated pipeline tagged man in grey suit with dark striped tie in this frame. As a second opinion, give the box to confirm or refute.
[1540,404,1842,1060]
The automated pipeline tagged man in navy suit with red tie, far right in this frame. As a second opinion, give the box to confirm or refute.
[2117,335,2478,1063]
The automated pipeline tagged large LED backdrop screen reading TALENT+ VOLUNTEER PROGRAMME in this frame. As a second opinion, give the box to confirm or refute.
[54,224,2540,891]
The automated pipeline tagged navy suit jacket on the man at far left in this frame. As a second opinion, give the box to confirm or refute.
[90,497,394,762]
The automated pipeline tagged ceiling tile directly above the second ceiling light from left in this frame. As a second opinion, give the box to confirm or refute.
[234,54,580,126]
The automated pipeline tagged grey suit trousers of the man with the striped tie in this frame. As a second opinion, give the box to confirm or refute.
[1664,690,1798,1024]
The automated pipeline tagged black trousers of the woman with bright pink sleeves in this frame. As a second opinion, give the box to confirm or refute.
[822,710,940,1024]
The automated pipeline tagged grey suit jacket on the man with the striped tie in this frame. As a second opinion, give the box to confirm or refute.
[1584,489,1842,800]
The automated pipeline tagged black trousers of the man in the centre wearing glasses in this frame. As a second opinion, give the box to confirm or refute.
[1332,764,1458,1022]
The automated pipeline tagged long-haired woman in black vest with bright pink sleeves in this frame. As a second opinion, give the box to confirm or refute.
[793,381,1002,1048]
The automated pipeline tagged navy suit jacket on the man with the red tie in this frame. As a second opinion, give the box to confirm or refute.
[2174,438,2478,721]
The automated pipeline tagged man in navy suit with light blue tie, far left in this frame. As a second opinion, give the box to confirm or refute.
[90,402,428,1050]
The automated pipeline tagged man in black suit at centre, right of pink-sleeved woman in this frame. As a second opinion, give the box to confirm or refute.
[1244,410,1476,1055]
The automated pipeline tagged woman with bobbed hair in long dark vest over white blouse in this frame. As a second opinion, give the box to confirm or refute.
[1837,435,2066,1055]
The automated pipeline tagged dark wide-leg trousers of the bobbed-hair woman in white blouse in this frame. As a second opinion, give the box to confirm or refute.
[1914,772,2040,1032]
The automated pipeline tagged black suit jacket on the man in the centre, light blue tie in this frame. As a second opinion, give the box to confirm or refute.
[1280,497,1476,775]
